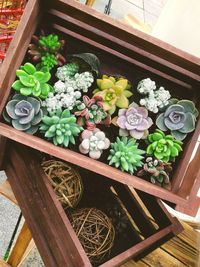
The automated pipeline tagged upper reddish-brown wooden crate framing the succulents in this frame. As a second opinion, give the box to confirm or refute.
[0,0,200,215]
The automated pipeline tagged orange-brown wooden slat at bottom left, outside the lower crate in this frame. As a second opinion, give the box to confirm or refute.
[8,222,32,267]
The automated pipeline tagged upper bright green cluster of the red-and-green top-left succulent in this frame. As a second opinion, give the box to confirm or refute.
[39,34,61,53]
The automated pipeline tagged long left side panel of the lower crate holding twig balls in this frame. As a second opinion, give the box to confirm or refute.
[6,145,91,267]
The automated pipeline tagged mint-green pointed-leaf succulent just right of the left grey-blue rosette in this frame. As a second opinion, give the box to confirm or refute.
[40,109,83,147]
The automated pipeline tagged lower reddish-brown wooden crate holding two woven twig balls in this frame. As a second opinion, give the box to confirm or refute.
[4,142,182,267]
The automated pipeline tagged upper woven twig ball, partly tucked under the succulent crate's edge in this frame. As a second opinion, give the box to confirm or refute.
[42,160,83,208]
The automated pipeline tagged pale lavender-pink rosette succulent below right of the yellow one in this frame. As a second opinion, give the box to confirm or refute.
[116,102,153,139]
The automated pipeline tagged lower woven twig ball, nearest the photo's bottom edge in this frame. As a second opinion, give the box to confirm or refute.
[69,208,115,264]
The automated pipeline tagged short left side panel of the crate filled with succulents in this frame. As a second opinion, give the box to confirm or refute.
[0,0,41,113]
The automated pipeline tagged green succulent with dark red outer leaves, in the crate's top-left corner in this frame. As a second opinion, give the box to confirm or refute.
[28,34,66,68]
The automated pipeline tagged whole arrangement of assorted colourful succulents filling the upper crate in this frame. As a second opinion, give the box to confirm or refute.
[3,30,199,189]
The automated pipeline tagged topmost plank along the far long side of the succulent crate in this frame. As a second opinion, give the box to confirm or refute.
[46,0,200,75]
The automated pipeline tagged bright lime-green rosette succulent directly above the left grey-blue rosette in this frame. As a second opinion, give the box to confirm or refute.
[12,63,52,99]
